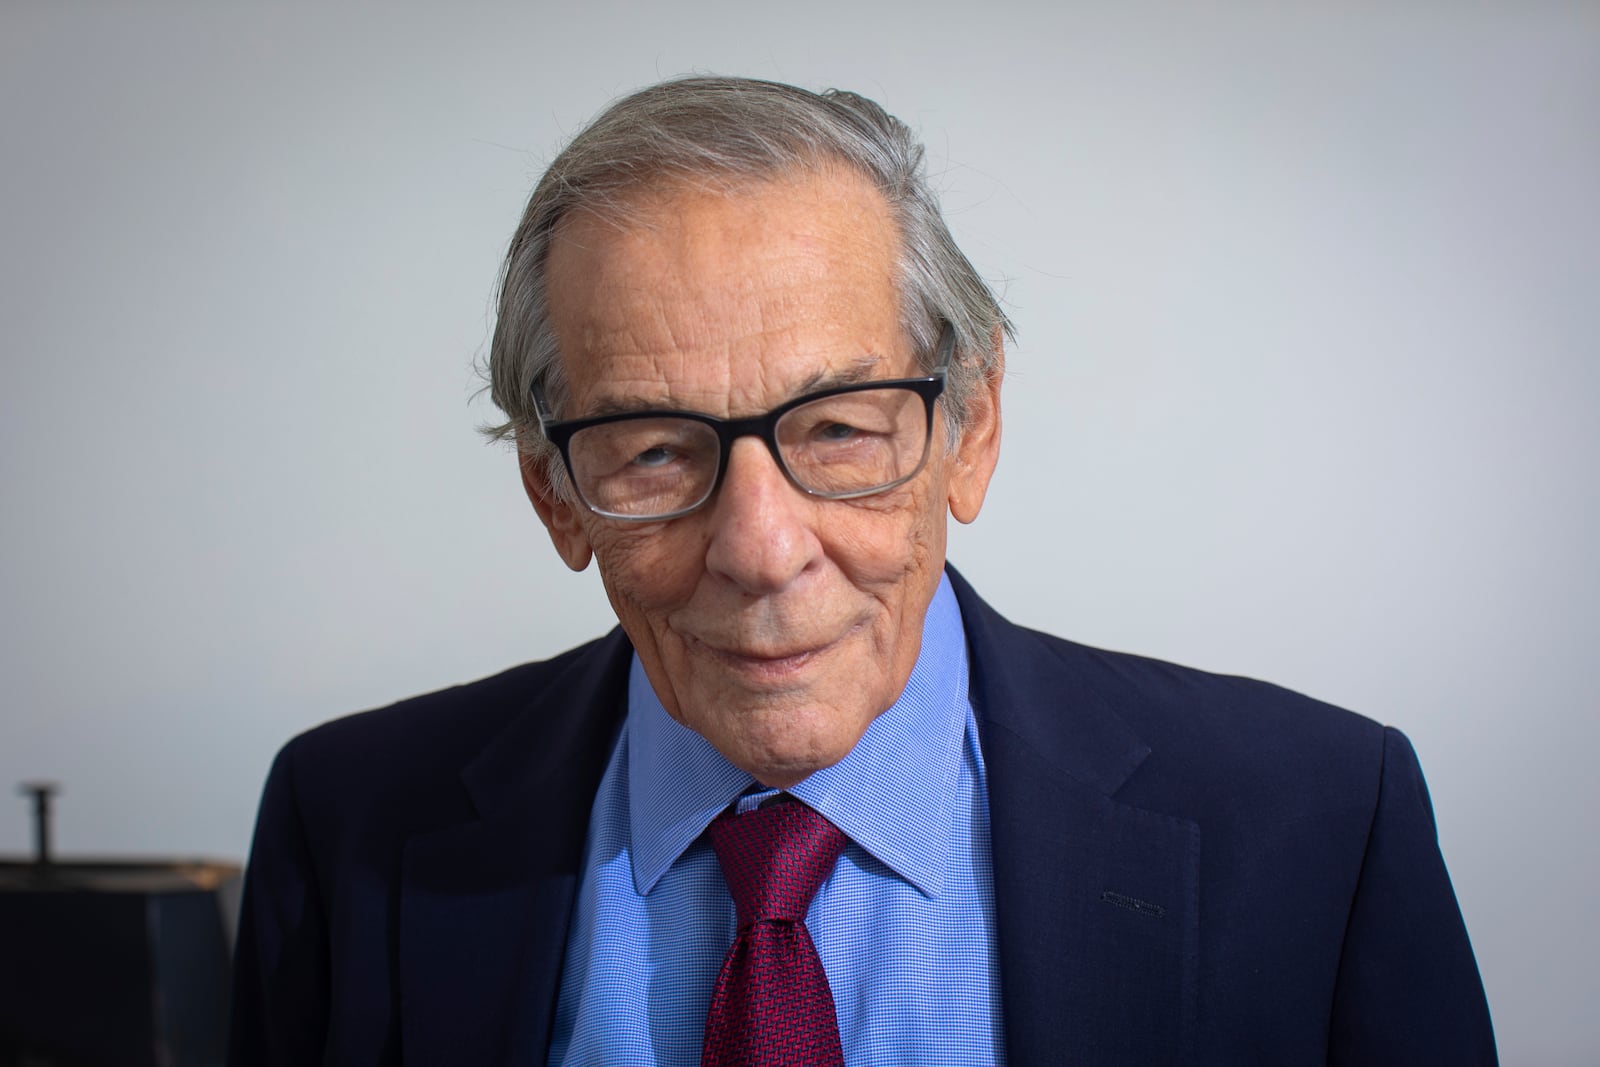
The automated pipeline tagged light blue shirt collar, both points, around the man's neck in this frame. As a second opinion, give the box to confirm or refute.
[624,576,968,896]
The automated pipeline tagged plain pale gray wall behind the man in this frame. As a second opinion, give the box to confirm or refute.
[0,0,1600,1064]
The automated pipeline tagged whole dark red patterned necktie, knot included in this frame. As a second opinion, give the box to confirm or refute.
[701,801,845,1067]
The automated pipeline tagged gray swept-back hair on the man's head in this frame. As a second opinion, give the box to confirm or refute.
[485,77,1011,493]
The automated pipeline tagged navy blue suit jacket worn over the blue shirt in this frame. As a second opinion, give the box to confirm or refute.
[230,573,1494,1067]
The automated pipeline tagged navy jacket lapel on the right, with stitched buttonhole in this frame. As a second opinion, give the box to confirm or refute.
[952,573,1200,1064]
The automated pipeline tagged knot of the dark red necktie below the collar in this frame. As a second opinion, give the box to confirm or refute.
[707,801,845,929]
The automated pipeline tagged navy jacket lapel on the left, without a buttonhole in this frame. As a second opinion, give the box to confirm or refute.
[398,630,632,1067]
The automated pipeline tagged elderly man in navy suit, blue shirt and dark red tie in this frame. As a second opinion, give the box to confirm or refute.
[232,78,1494,1065]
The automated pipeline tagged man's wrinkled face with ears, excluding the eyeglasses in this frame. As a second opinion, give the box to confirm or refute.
[523,170,998,787]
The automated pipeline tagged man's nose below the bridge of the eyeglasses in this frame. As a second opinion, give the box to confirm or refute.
[706,437,821,595]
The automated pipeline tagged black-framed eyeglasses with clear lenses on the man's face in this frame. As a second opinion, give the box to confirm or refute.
[533,323,955,522]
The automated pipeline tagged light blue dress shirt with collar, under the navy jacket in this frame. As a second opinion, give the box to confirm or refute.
[549,579,1003,1067]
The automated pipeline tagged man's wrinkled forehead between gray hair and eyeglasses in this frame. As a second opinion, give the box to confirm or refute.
[546,171,910,418]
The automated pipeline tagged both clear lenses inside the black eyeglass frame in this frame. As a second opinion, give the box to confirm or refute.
[568,387,928,518]
